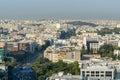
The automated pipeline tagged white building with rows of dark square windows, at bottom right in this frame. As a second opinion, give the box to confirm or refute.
[81,64,115,80]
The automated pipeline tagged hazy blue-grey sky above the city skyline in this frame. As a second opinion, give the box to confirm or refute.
[0,0,120,20]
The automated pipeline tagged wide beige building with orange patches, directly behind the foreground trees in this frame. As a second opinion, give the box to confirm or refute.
[44,46,81,62]
